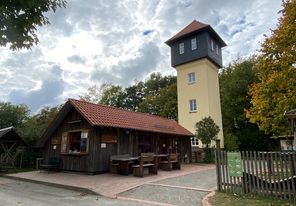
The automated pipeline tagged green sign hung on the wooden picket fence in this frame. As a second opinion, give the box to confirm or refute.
[227,152,243,177]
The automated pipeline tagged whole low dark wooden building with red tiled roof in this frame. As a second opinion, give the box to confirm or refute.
[37,99,193,173]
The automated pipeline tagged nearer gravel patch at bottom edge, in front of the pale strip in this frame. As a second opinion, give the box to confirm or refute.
[120,185,207,206]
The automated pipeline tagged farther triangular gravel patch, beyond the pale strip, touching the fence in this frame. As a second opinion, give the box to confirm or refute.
[155,169,217,190]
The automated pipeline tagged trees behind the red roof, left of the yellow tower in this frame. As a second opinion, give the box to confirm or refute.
[85,73,178,120]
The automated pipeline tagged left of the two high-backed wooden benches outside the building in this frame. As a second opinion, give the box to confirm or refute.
[133,153,157,177]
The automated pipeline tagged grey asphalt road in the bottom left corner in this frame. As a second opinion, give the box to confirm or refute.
[0,177,145,206]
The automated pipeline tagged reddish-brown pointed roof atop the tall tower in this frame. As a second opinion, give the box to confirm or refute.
[165,20,226,47]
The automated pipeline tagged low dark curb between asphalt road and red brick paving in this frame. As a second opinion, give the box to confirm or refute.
[1,175,99,196]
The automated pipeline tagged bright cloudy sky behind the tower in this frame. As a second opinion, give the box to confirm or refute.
[0,0,281,113]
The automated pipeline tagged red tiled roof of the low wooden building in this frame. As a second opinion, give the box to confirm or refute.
[69,99,193,136]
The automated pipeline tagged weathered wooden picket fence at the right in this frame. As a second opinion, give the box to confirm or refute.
[215,150,296,200]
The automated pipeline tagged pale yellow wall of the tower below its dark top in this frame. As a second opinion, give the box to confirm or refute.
[176,59,224,147]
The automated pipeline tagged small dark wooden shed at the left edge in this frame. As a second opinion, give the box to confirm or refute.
[0,127,27,168]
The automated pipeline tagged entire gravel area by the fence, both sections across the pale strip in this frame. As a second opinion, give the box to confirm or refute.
[119,169,216,206]
